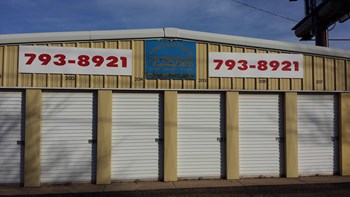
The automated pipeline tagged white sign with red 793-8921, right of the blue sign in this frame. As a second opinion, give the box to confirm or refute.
[209,52,304,78]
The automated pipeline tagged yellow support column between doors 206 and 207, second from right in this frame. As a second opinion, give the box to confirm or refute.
[284,92,298,178]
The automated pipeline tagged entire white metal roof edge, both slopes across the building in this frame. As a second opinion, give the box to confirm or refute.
[0,28,350,58]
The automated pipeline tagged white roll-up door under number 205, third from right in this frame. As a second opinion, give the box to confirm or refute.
[177,94,225,178]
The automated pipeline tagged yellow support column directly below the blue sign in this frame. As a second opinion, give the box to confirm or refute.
[164,91,177,181]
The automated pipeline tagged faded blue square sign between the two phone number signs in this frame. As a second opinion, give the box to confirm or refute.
[145,40,196,80]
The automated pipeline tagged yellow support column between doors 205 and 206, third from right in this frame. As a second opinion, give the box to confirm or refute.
[226,92,239,180]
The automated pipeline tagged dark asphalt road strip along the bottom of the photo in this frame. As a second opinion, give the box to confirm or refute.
[0,183,350,197]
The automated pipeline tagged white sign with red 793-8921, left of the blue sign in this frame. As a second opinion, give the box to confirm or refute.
[19,46,132,76]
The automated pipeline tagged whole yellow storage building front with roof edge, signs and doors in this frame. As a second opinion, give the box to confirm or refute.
[0,28,350,187]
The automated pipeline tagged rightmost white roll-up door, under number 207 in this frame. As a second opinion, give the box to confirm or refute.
[298,95,338,176]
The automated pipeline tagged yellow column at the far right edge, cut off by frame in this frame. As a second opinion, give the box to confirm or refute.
[339,93,350,176]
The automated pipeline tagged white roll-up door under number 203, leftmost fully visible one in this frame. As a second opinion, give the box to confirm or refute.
[41,92,95,182]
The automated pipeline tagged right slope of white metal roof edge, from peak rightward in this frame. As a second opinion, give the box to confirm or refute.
[165,28,350,58]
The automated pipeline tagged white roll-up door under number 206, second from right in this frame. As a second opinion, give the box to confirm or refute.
[239,94,284,177]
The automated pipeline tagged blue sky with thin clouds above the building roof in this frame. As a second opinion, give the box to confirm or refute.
[0,0,350,50]
